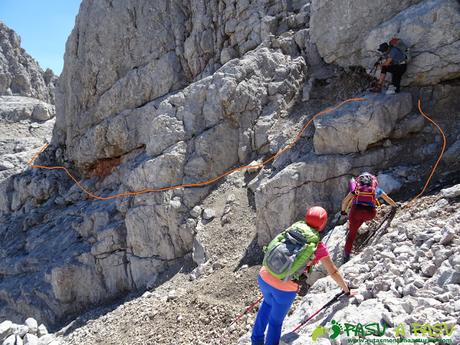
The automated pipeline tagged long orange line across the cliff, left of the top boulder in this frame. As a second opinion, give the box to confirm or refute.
[28,98,365,200]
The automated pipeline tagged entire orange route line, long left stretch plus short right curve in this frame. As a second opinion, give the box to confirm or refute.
[28,97,446,207]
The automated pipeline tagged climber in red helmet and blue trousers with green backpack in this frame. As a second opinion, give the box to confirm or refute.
[251,206,355,345]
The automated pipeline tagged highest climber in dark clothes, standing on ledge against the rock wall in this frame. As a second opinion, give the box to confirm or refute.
[373,38,409,94]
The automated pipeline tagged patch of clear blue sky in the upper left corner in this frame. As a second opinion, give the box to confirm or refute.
[0,0,81,75]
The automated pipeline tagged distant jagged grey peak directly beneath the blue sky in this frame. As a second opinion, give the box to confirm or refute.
[0,22,56,103]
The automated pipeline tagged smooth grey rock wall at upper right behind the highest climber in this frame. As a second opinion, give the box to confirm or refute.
[310,0,460,85]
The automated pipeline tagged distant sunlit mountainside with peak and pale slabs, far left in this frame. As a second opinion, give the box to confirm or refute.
[0,22,57,181]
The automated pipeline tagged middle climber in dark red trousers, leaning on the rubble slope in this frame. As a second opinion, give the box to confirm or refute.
[341,172,397,262]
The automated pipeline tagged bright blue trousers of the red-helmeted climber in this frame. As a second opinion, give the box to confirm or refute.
[251,276,297,345]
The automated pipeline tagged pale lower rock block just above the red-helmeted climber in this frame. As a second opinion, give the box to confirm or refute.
[255,147,398,245]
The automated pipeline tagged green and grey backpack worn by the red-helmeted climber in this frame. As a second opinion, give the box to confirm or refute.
[262,221,320,281]
